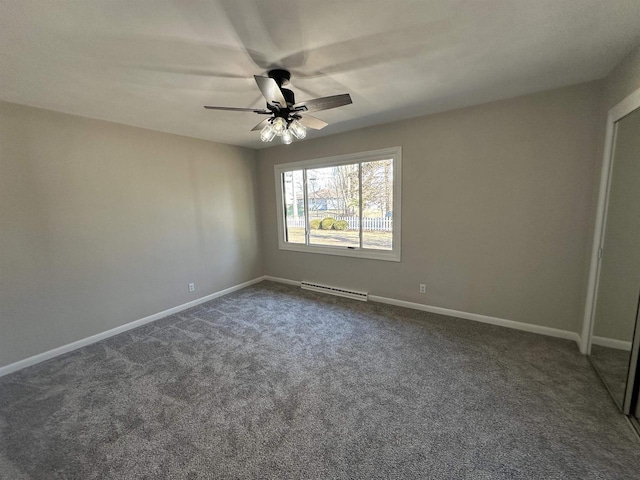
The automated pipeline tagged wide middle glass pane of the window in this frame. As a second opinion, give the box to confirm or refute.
[307,163,360,248]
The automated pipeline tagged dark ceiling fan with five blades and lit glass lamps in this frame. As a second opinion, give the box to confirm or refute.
[204,69,351,145]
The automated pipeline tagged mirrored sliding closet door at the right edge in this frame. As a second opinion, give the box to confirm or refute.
[590,109,640,413]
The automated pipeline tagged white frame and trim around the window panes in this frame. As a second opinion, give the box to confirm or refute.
[274,147,402,262]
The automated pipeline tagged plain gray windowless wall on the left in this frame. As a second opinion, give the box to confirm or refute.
[0,103,262,365]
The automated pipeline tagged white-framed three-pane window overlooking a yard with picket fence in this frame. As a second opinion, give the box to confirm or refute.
[275,147,401,262]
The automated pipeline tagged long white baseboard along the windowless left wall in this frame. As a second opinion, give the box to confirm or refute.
[0,276,266,377]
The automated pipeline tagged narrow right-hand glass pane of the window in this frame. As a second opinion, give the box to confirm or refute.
[362,160,393,250]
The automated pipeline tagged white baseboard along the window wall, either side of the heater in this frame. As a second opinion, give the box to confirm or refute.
[264,275,581,348]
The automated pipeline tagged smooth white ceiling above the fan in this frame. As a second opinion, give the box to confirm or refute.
[0,0,640,148]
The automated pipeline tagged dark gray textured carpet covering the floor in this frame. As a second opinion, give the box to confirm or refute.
[0,282,640,479]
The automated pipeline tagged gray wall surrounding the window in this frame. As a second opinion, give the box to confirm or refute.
[258,82,602,332]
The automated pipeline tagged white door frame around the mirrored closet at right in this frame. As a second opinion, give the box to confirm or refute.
[580,88,640,355]
